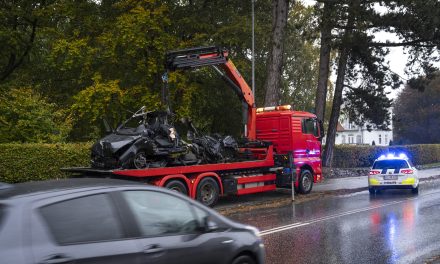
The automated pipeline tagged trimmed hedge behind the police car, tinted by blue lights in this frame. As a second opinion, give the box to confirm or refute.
[332,144,440,168]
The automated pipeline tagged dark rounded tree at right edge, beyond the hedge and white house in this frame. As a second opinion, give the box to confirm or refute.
[393,72,440,144]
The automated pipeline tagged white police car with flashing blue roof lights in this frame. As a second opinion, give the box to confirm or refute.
[368,154,419,194]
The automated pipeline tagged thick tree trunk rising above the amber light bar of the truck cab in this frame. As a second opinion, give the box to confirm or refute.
[264,0,289,106]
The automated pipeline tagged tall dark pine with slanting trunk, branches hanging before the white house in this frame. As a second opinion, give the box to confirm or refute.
[317,0,439,165]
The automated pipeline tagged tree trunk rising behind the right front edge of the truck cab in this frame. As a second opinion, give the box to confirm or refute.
[315,3,332,121]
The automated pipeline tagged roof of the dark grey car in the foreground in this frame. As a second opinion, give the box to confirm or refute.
[0,178,139,199]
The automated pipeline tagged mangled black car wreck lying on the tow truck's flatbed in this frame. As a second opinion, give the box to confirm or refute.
[91,106,238,169]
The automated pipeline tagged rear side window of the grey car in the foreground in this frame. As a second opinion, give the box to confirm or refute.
[40,194,123,245]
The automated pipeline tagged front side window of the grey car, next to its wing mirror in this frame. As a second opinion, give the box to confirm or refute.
[123,191,198,237]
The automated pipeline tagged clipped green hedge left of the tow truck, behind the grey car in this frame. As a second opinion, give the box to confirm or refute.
[0,143,91,183]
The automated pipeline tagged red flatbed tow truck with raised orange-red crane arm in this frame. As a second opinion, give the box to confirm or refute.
[66,47,322,206]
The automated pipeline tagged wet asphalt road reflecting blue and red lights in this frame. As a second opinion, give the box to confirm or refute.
[229,180,440,263]
